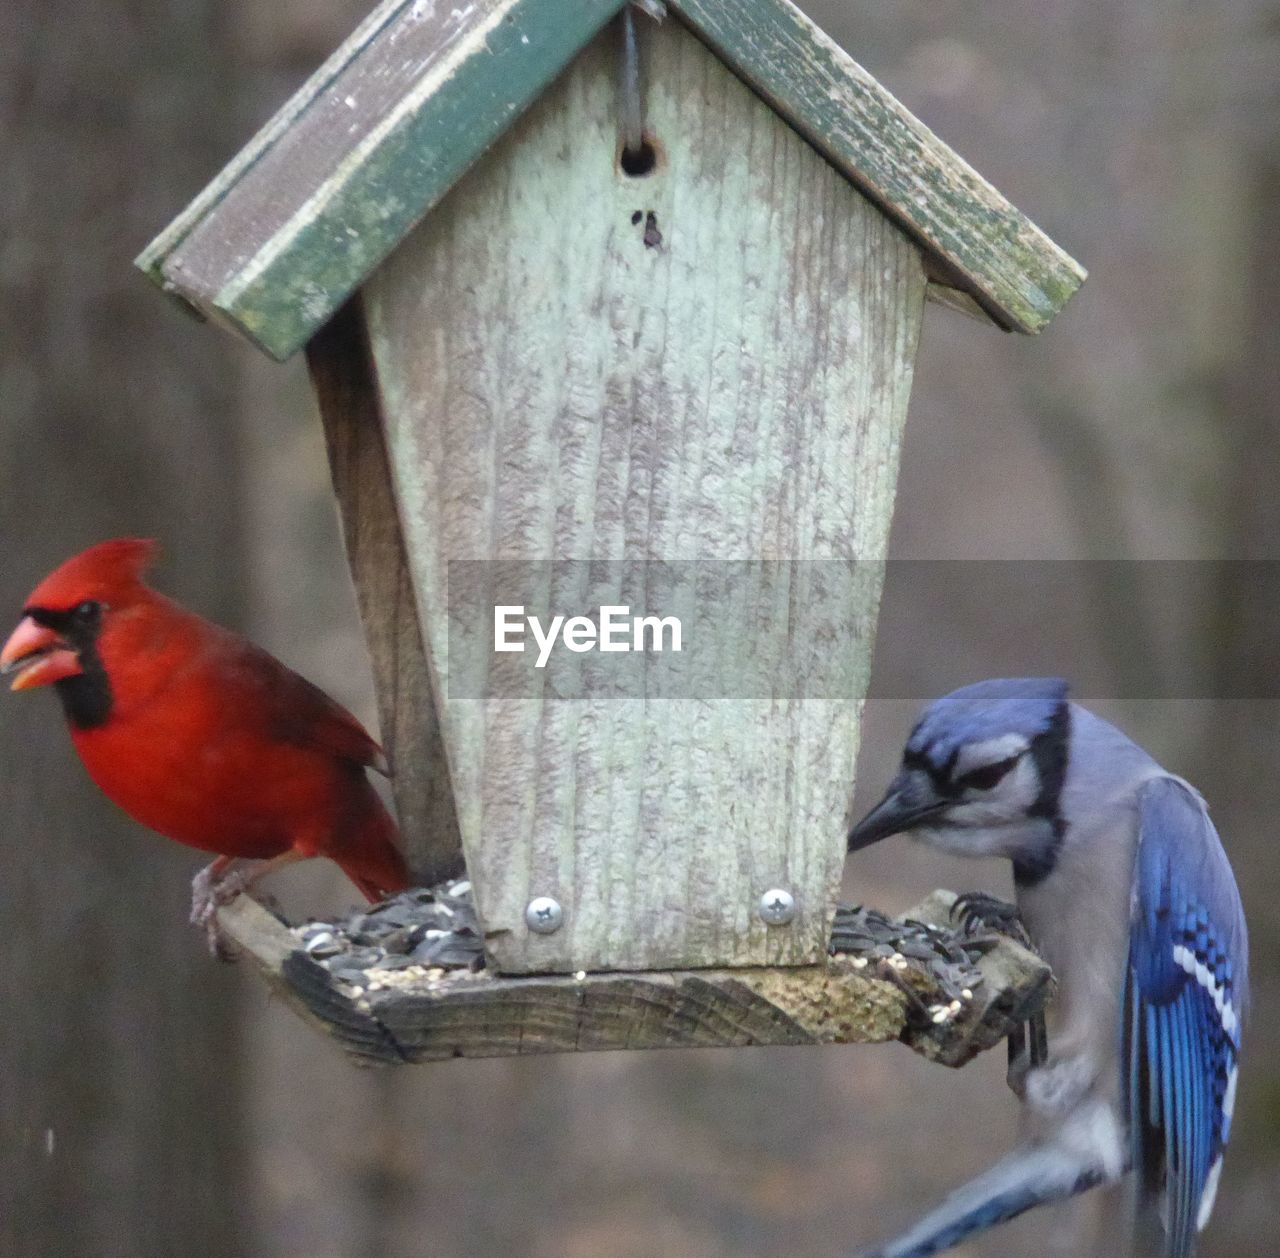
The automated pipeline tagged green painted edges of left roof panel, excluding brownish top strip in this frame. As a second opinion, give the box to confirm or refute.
[136,0,626,361]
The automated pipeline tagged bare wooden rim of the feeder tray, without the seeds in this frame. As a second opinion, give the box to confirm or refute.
[219,893,1052,1066]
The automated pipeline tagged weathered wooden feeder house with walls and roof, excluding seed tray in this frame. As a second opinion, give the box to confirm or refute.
[140,0,1084,1064]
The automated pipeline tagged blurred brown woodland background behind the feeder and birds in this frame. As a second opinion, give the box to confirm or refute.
[0,0,1280,1258]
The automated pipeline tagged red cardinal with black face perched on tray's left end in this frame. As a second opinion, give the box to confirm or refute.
[0,537,408,938]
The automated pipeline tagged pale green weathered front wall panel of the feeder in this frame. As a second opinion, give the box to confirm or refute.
[365,23,925,971]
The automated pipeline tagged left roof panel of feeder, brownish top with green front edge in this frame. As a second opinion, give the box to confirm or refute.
[138,0,623,358]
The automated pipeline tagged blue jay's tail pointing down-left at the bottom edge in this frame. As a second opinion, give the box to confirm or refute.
[860,1100,1124,1258]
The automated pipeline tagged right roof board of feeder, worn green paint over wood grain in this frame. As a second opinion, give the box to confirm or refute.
[671,0,1085,333]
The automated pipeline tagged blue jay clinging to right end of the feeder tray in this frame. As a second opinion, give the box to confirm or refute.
[849,678,1248,1258]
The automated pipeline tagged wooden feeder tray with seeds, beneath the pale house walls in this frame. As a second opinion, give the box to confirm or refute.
[219,891,1053,1066]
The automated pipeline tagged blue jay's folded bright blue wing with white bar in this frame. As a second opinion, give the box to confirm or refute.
[1121,777,1248,1258]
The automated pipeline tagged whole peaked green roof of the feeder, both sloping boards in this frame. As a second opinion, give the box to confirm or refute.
[138,0,1084,360]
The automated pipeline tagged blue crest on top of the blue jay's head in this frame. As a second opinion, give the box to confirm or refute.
[906,677,1068,772]
